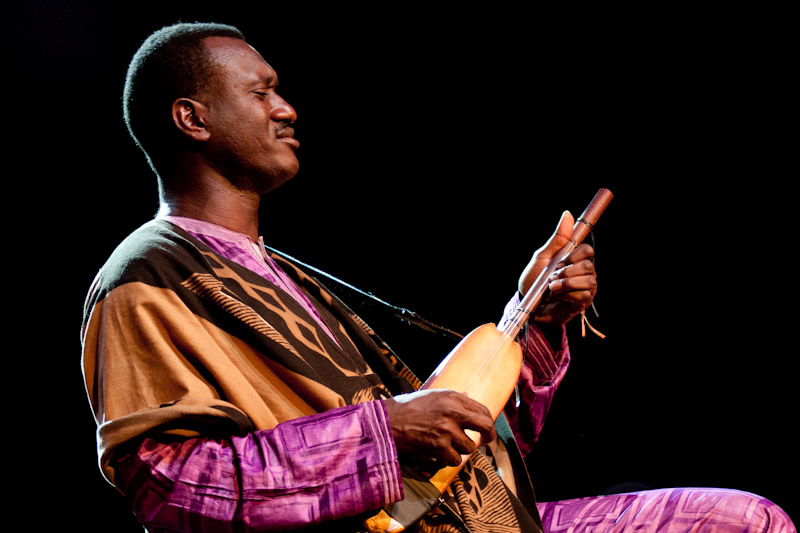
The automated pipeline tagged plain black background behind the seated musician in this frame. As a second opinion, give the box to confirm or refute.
[3,1,798,532]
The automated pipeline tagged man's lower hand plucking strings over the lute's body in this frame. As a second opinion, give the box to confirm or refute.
[384,390,497,472]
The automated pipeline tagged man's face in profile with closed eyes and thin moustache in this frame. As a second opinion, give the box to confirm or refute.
[198,37,299,194]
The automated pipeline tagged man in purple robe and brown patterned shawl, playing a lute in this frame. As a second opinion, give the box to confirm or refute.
[82,24,792,532]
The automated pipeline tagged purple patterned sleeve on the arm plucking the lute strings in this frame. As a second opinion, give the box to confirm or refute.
[117,401,403,531]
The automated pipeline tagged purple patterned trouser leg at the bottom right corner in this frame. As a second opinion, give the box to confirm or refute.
[538,488,797,533]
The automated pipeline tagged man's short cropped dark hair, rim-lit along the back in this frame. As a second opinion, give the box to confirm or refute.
[122,22,245,173]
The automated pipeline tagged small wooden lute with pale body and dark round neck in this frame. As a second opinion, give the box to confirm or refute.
[364,189,613,533]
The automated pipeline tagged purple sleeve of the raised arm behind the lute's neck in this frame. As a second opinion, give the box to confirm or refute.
[500,295,570,455]
